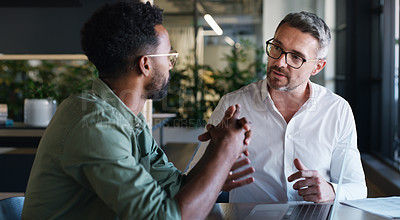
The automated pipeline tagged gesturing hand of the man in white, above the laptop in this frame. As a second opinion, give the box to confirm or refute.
[288,158,335,202]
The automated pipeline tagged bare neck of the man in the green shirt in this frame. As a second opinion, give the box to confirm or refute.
[103,77,146,115]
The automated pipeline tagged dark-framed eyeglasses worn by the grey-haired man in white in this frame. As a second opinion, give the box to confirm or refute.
[265,38,319,69]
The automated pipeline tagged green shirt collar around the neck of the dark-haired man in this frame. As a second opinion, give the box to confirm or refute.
[92,78,146,133]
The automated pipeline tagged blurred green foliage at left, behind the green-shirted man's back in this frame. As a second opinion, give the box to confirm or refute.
[0,60,97,121]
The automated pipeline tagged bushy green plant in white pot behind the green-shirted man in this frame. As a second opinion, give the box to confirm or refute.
[24,60,97,127]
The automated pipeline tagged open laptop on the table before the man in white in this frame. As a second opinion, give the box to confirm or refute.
[246,133,353,220]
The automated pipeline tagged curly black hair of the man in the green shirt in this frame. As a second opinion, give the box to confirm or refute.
[81,0,163,78]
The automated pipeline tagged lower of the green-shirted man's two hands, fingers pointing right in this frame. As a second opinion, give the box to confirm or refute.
[222,157,254,192]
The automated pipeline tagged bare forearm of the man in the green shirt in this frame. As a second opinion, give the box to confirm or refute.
[176,142,236,219]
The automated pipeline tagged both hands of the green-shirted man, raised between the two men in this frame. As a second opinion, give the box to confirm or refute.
[198,104,254,191]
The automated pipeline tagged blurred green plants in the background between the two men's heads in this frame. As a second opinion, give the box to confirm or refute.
[154,38,266,127]
